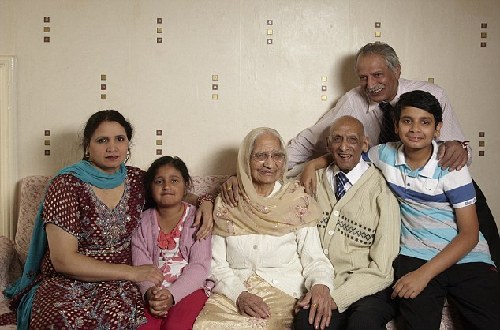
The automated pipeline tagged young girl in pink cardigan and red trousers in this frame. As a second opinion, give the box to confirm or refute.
[132,156,211,329]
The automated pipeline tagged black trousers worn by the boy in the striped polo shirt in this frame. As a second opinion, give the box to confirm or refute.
[395,255,500,330]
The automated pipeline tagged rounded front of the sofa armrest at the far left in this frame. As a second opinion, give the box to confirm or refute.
[0,236,23,291]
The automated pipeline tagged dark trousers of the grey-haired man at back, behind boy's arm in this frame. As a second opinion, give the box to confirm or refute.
[472,180,500,269]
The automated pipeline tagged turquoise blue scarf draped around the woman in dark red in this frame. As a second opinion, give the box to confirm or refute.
[4,160,127,330]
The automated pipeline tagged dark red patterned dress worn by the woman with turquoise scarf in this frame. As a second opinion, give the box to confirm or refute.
[30,167,146,329]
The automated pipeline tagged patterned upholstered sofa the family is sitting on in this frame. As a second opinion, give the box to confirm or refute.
[0,175,462,329]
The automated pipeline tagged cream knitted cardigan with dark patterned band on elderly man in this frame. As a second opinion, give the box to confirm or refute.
[316,164,401,312]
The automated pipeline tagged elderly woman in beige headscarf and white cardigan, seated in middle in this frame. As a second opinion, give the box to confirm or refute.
[194,128,333,329]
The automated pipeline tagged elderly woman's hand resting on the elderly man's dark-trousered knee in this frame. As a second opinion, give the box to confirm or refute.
[295,284,337,329]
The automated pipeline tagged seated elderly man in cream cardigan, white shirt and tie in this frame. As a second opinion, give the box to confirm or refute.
[294,116,400,330]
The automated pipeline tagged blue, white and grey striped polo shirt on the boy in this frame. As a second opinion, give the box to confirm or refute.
[368,141,493,264]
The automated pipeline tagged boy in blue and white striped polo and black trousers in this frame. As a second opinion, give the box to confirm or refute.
[369,90,500,329]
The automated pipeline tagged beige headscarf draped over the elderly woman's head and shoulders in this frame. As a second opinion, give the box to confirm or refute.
[213,127,321,237]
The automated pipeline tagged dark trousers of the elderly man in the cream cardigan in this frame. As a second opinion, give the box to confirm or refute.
[293,288,395,330]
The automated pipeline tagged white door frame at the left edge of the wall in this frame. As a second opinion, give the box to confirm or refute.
[0,55,17,239]
